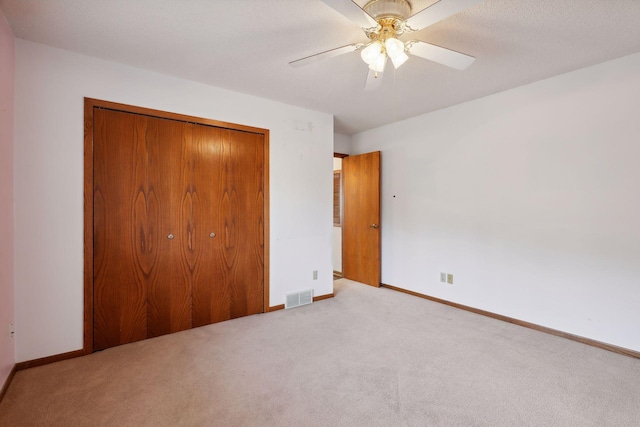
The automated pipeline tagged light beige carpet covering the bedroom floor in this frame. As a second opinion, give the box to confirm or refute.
[0,279,640,427]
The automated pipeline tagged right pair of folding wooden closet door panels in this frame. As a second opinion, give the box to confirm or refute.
[192,125,264,326]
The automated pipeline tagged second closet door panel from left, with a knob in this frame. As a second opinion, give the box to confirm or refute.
[147,118,191,337]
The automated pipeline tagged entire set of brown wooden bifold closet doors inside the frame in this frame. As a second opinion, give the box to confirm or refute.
[93,108,265,350]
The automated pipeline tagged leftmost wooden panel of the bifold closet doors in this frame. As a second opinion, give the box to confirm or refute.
[93,109,149,350]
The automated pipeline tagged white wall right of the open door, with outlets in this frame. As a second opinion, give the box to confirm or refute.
[352,54,640,351]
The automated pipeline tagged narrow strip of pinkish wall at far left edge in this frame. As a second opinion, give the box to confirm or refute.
[0,11,15,388]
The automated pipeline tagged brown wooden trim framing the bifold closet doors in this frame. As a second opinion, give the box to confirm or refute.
[83,98,269,354]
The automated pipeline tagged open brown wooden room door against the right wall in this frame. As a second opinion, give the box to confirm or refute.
[342,151,380,287]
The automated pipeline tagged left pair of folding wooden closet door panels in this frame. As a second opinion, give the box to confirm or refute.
[93,109,191,350]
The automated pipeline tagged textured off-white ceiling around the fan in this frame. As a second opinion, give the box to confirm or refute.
[0,0,640,134]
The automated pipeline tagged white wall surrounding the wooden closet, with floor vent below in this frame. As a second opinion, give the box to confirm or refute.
[13,39,333,361]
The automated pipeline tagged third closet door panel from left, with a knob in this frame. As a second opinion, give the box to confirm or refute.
[191,125,231,326]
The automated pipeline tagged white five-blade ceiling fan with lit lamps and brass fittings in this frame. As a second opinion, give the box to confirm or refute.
[289,0,482,90]
